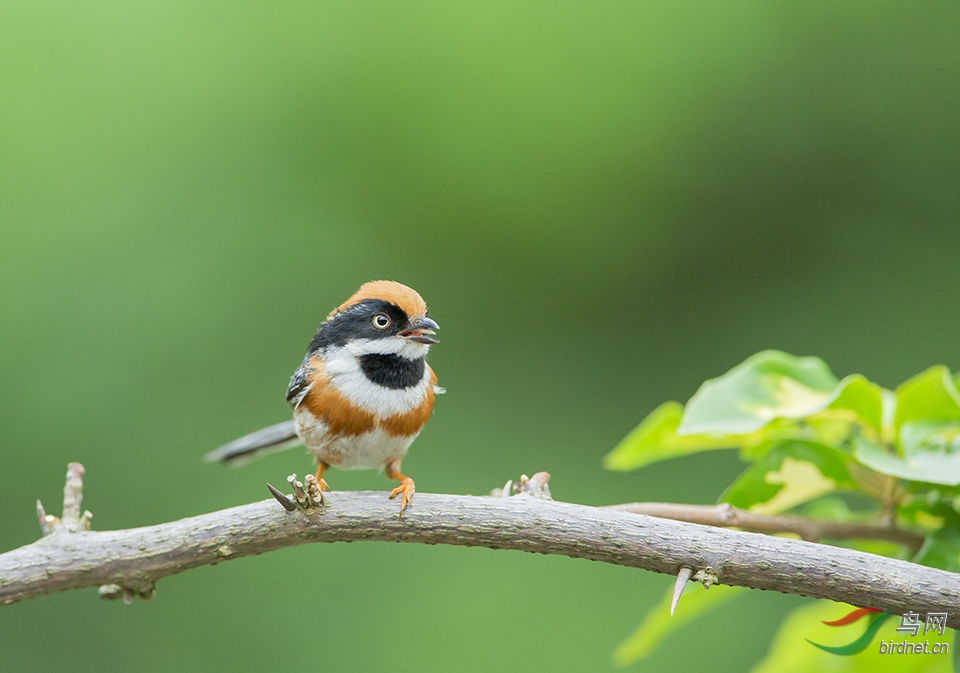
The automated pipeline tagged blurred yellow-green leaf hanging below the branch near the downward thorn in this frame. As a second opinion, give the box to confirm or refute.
[613,582,745,666]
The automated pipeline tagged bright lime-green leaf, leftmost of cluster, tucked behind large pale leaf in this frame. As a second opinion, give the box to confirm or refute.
[603,402,738,472]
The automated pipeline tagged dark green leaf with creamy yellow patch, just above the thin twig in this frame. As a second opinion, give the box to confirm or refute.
[720,440,856,514]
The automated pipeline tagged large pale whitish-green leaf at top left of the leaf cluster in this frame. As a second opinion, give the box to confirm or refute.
[677,351,838,436]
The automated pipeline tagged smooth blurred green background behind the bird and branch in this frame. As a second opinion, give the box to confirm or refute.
[0,1,960,672]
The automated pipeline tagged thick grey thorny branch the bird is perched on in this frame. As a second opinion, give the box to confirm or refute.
[0,462,960,628]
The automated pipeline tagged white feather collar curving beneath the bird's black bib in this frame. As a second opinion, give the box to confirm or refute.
[323,346,430,418]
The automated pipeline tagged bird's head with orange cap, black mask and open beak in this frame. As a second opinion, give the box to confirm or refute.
[311,280,440,359]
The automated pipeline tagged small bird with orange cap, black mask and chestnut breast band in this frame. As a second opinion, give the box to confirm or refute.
[205,280,444,515]
